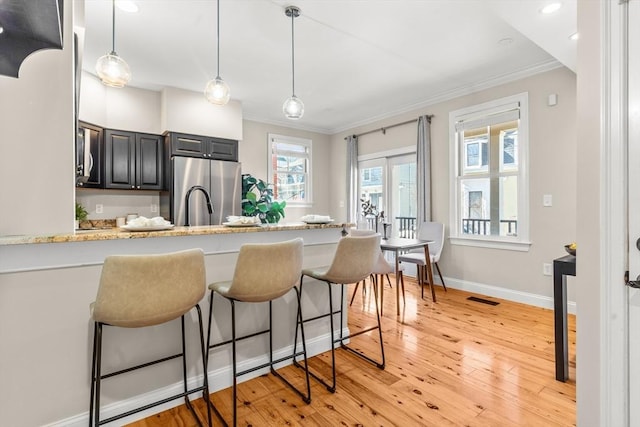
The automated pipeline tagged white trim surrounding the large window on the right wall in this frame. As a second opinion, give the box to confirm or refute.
[449,92,531,251]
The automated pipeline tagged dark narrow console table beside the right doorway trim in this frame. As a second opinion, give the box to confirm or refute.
[553,255,576,382]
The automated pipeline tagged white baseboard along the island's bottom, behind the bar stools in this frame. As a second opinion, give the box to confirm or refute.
[43,328,349,427]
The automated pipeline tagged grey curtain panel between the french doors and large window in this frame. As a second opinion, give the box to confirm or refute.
[416,116,431,224]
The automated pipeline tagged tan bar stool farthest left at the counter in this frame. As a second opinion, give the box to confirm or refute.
[89,249,211,426]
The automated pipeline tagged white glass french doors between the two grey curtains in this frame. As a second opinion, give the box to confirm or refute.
[359,153,417,237]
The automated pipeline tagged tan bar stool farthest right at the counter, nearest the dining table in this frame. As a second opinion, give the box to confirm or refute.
[294,234,385,393]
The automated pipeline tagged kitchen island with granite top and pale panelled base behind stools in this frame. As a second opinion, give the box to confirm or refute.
[0,223,350,426]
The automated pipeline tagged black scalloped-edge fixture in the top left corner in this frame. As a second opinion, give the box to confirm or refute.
[0,0,64,78]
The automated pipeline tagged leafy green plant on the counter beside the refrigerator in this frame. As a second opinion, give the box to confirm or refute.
[242,174,287,224]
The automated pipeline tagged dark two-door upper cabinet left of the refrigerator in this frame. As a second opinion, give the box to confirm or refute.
[105,129,164,190]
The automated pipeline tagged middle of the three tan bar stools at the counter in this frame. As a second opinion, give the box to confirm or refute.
[207,238,311,426]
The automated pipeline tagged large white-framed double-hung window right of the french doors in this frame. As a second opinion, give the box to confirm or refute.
[449,92,531,251]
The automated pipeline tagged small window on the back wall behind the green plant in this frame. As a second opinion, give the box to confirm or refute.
[268,134,312,205]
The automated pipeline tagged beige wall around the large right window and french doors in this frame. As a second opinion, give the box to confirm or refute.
[331,68,577,306]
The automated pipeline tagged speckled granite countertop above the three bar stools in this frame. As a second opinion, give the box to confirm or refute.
[0,222,352,246]
